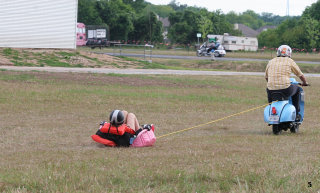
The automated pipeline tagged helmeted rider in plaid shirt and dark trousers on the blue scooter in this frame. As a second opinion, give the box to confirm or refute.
[265,45,308,120]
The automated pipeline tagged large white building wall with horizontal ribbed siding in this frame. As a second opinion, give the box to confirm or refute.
[0,0,78,49]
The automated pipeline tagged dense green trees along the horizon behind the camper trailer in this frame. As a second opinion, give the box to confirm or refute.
[78,0,320,48]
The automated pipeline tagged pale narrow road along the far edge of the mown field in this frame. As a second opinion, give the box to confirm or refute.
[0,66,320,77]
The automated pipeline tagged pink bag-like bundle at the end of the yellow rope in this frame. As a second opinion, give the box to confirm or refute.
[131,129,156,147]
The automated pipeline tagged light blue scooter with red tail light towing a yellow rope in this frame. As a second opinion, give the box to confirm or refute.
[264,78,304,135]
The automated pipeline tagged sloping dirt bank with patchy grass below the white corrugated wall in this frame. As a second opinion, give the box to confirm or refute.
[0,48,143,68]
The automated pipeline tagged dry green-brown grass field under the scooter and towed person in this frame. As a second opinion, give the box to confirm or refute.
[0,71,320,193]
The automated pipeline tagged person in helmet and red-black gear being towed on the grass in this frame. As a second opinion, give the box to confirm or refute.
[91,110,154,147]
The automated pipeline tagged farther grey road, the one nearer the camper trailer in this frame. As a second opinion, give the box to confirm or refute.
[100,52,320,64]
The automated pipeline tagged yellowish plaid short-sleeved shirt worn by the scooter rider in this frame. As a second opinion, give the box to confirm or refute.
[265,57,303,90]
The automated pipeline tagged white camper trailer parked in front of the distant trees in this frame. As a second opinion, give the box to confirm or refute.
[207,34,258,51]
